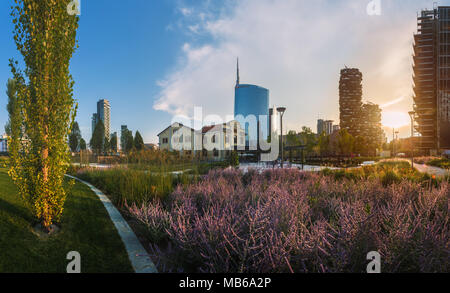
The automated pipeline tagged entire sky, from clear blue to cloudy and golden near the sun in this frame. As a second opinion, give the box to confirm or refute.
[0,0,450,143]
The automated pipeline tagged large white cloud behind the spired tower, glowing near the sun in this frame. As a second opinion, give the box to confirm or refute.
[154,0,431,129]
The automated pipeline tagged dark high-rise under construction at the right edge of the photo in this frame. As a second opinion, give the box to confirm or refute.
[413,6,450,154]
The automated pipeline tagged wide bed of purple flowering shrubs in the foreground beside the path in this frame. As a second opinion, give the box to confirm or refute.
[128,170,450,273]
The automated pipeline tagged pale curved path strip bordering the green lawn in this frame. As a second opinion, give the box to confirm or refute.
[66,175,158,274]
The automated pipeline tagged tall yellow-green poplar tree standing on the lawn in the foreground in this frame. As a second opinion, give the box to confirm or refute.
[9,0,78,231]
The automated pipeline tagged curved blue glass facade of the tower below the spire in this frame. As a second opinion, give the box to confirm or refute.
[234,84,269,146]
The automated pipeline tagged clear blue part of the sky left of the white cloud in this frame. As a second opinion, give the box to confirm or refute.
[0,0,197,141]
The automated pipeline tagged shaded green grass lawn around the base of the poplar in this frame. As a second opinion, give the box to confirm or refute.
[0,167,133,273]
